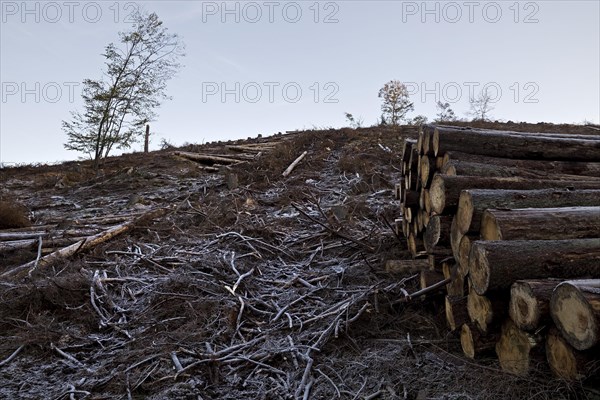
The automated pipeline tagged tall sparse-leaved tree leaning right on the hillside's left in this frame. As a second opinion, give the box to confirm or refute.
[62,13,183,168]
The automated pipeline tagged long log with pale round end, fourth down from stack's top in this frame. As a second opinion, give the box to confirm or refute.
[429,174,600,215]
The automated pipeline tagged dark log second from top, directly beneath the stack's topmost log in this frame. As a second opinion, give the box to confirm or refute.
[439,151,600,178]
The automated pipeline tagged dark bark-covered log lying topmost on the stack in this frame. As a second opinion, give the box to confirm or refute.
[433,126,600,161]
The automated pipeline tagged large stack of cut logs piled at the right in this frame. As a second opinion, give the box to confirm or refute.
[396,125,600,380]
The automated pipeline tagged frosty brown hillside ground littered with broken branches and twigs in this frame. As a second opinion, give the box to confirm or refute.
[0,124,597,400]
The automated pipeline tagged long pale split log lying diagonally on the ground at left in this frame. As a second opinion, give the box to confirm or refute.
[0,208,168,279]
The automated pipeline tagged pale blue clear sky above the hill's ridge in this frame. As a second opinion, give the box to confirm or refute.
[0,0,600,165]
